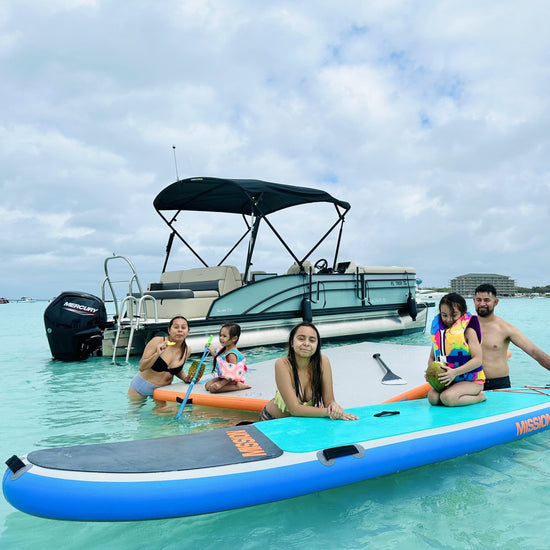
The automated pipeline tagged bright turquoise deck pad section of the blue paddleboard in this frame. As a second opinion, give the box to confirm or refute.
[256,390,550,453]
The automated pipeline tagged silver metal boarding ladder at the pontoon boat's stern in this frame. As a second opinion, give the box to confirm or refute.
[101,254,158,363]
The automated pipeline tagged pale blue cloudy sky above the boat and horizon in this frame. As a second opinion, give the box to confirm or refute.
[0,0,550,298]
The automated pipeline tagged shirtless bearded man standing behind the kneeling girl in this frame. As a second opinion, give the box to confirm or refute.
[474,284,550,390]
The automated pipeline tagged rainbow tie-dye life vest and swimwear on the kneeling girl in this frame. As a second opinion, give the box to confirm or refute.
[430,313,485,382]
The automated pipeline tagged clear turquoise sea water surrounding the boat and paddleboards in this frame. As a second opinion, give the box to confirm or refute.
[0,299,550,550]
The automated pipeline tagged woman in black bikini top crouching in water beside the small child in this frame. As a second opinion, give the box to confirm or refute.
[128,316,191,406]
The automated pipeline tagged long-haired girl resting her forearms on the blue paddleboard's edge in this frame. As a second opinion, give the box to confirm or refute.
[260,322,357,420]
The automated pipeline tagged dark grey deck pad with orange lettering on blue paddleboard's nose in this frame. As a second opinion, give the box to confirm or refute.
[27,425,283,474]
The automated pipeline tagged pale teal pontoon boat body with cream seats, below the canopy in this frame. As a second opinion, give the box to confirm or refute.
[103,264,429,356]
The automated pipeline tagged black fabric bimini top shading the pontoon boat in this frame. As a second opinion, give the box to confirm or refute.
[153,178,350,216]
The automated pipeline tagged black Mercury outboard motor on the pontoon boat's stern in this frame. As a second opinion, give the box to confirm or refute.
[44,292,107,361]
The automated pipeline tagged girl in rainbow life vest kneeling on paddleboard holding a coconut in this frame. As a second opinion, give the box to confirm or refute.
[428,292,487,407]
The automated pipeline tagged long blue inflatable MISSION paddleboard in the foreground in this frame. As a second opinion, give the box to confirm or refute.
[3,391,550,520]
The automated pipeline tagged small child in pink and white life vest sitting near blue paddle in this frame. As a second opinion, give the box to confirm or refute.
[204,323,251,393]
